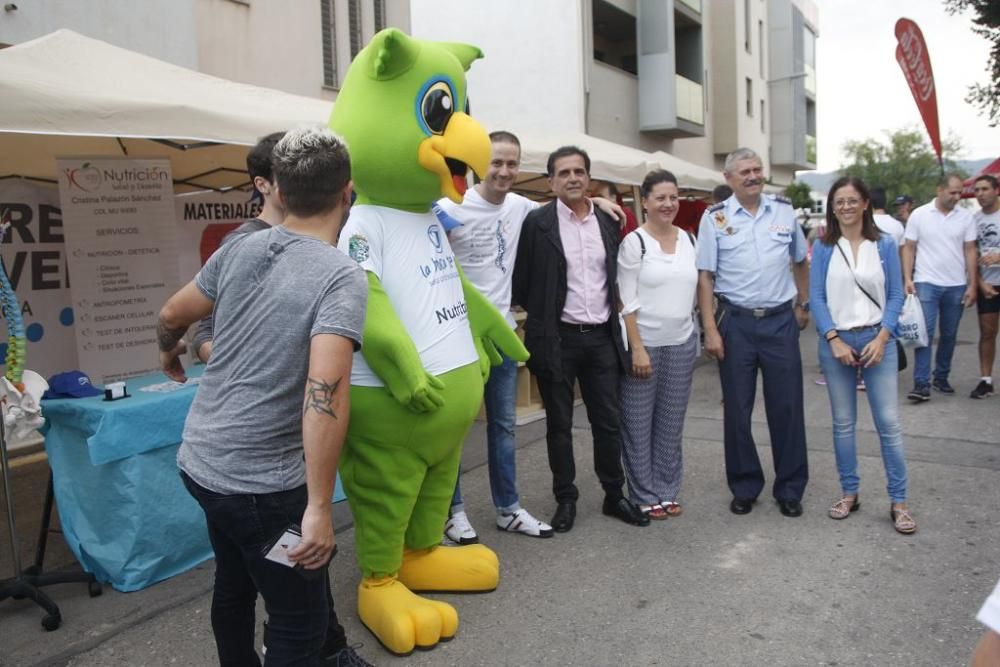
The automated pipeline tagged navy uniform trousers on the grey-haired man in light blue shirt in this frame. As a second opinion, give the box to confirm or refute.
[716,304,809,500]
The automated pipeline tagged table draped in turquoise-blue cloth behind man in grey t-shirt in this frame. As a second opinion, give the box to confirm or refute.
[41,366,352,592]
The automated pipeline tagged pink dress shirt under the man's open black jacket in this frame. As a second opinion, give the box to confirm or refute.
[556,200,611,324]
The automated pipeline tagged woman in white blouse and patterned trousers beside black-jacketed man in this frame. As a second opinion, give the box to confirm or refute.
[618,169,698,519]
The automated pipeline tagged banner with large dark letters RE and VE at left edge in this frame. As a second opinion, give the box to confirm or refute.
[0,178,79,378]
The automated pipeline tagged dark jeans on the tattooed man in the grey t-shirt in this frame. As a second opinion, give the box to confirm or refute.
[181,472,347,667]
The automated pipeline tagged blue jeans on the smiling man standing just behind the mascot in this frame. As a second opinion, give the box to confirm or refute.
[451,356,521,514]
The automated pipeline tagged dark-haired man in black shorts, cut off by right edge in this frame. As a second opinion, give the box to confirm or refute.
[969,174,1000,398]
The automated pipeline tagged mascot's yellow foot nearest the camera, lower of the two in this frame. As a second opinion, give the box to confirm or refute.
[358,577,458,656]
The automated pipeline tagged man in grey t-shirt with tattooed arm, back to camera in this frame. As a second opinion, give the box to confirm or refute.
[157,128,367,665]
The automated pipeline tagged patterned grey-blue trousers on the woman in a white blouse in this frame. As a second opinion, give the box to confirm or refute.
[621,334,698,505]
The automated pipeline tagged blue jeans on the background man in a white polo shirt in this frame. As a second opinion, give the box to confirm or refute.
[913,283,965,386]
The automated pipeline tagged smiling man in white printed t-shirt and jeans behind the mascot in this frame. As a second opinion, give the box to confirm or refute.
[438,131,552,544]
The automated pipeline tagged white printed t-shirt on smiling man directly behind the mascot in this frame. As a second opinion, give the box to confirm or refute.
[438,188,538,328]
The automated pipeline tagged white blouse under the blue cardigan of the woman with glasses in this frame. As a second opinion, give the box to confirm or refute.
[826,238,885,329]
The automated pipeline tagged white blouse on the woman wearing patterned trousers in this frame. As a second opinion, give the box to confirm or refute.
[618,228,698,347]
